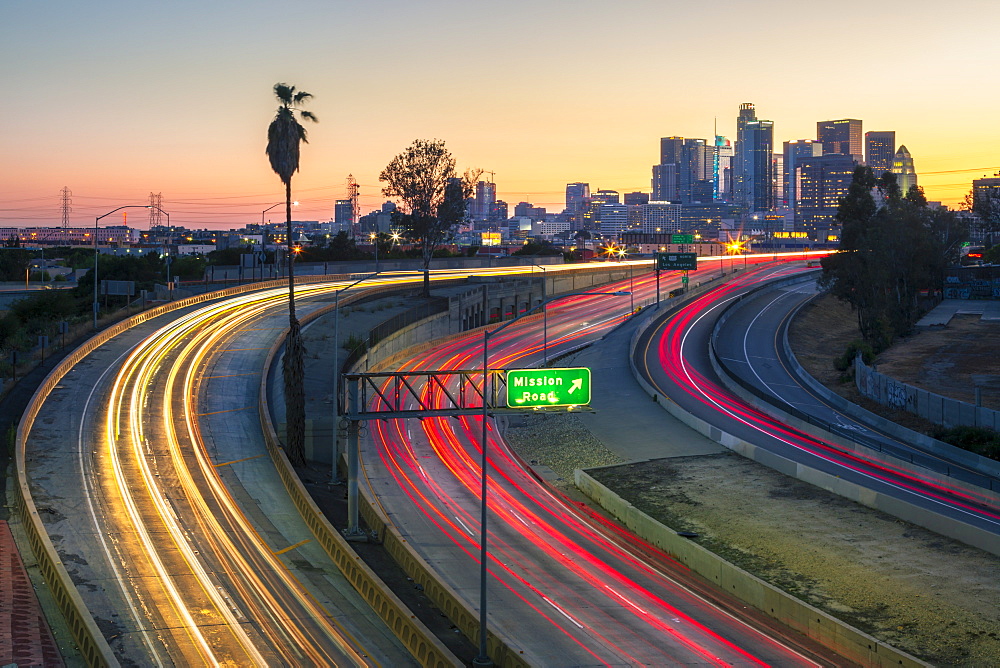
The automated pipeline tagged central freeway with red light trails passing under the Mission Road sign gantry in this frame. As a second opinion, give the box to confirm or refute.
[362,262,829,665]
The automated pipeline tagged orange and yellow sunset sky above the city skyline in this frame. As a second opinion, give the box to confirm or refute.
[0,0,1000,228]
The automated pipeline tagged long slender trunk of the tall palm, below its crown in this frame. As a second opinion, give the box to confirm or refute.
[282,179,306,466]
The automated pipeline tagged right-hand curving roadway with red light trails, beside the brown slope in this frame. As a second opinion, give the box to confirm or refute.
[634,272,1000,535]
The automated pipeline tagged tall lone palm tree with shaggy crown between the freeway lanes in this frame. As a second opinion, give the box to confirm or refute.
[266,83,318,466]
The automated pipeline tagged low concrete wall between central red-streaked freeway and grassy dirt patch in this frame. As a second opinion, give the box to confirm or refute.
[574,469,928,667]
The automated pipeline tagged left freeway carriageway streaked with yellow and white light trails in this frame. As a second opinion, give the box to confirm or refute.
[29,279,436,666]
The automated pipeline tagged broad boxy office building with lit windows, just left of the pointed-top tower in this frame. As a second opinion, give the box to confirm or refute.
[794,153,855,231]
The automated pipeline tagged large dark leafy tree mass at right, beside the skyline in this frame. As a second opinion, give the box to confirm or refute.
[821,167,967,351]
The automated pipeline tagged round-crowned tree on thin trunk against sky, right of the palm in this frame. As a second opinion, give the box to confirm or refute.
[378,139,483,297]
